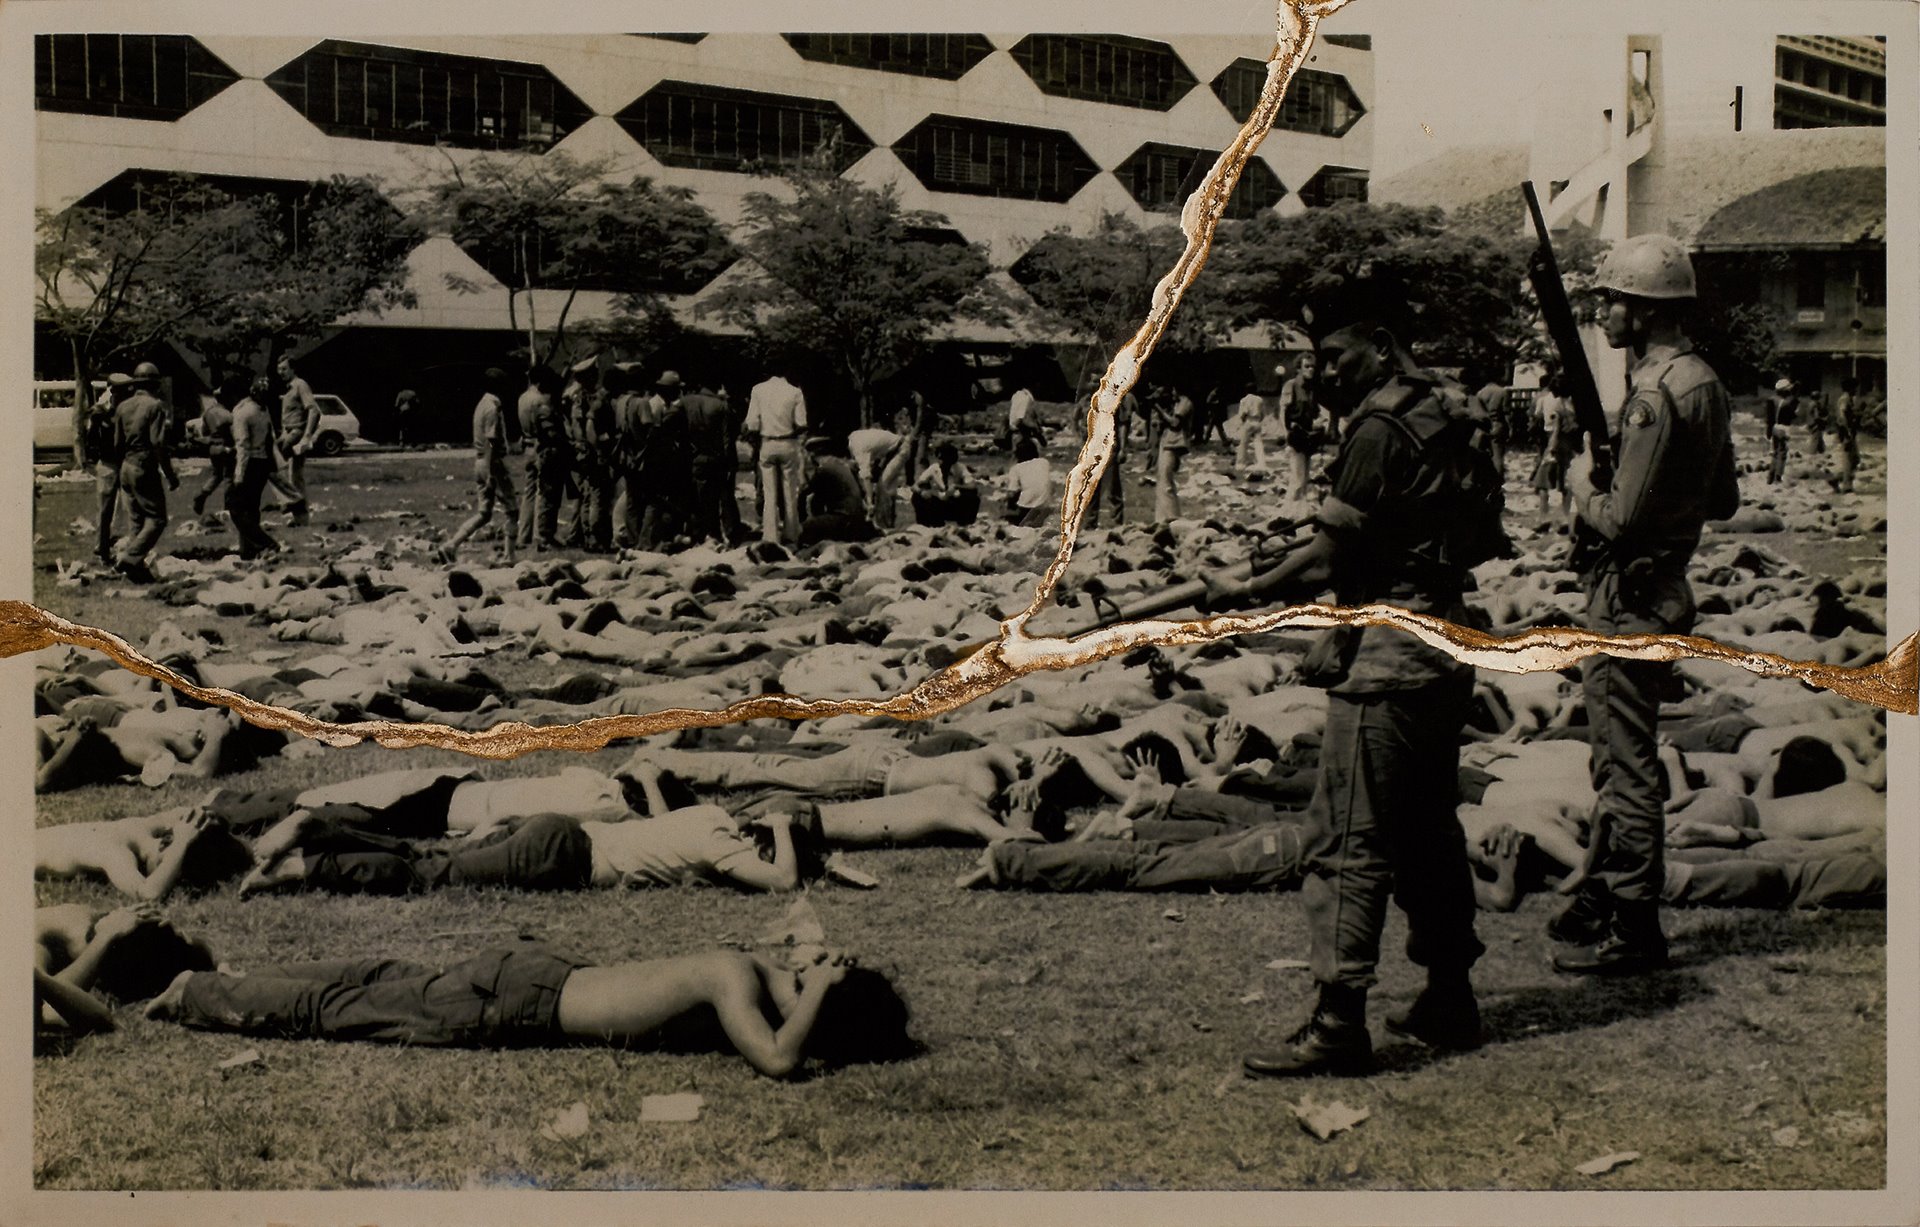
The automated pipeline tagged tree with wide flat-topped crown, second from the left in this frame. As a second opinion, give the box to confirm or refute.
[415,152,735,363]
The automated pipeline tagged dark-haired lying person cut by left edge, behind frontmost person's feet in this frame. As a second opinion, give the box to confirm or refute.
[33,902,213,1031]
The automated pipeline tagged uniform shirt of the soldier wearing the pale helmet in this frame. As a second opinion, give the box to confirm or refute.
[1574,344,1738,570]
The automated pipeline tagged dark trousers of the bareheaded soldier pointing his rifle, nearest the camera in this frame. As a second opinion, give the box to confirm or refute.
[1300,674,1486,989]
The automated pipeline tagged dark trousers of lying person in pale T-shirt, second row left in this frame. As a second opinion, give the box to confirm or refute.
[301,814,593,895]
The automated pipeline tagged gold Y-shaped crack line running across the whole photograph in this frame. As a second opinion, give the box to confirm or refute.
[11,0,1920,758]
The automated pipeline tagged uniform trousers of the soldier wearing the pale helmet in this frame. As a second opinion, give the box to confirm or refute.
[1580,570,1693,902]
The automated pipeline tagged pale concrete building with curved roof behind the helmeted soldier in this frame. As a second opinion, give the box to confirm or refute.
[1377,29,1887,399]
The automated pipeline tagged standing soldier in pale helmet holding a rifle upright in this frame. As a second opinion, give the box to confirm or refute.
[1548,234,1740,974]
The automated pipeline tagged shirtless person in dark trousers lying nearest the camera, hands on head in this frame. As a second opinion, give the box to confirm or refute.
[146,945,916,1077]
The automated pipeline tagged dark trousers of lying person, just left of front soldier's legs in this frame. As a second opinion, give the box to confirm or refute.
[987,822,1304,891]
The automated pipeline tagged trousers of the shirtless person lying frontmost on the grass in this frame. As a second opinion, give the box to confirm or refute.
[175,945,586,1048]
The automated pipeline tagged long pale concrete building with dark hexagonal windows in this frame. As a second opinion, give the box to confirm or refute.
[35,35,1373,436]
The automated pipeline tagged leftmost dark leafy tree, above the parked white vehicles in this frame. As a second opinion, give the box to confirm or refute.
[35,175,417,457]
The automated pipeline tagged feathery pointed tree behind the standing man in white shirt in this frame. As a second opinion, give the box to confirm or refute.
[707,144,1010,426]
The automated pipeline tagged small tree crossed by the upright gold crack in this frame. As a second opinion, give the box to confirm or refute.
[1012,213,1225,396]
